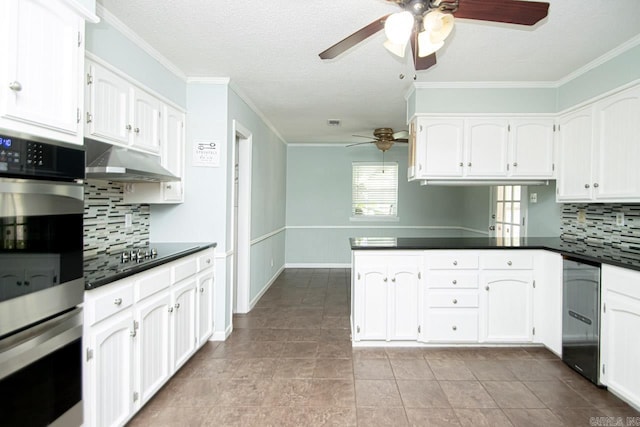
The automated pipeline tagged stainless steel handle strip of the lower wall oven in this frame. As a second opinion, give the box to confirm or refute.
[0,308,82,379]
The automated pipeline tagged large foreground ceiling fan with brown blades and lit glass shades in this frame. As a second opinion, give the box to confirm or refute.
[320,0,549,70]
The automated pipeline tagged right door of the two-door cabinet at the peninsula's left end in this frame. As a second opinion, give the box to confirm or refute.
[388,257,421,340]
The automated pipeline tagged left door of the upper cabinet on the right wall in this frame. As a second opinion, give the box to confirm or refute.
[556,106,593,201]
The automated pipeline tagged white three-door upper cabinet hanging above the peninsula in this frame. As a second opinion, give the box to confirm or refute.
[408,116,554,181]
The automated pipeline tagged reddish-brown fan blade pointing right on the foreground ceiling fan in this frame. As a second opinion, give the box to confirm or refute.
[453,0,549,25]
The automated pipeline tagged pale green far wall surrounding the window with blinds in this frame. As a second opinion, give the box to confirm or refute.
[286,144,476,265]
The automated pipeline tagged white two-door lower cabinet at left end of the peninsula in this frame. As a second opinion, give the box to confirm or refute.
[352,251,422,341]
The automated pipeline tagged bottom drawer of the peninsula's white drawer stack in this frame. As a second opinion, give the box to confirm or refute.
[425,308,478,342]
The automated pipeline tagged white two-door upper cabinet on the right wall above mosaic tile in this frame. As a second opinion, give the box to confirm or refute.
[557,86,640,203]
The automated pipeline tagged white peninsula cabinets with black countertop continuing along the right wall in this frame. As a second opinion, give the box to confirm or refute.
[350,237,640,407]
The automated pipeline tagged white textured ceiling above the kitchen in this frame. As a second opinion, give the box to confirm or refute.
[98,0,640,142]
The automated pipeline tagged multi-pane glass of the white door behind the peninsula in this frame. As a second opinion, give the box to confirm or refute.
[491,185,527,239]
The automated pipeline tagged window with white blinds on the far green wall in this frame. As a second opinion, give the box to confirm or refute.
[351,162,398,219]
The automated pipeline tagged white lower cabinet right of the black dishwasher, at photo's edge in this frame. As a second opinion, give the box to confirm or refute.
[600,265,640,408]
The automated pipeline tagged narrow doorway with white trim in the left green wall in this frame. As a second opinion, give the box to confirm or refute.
[230,120,252,313]
